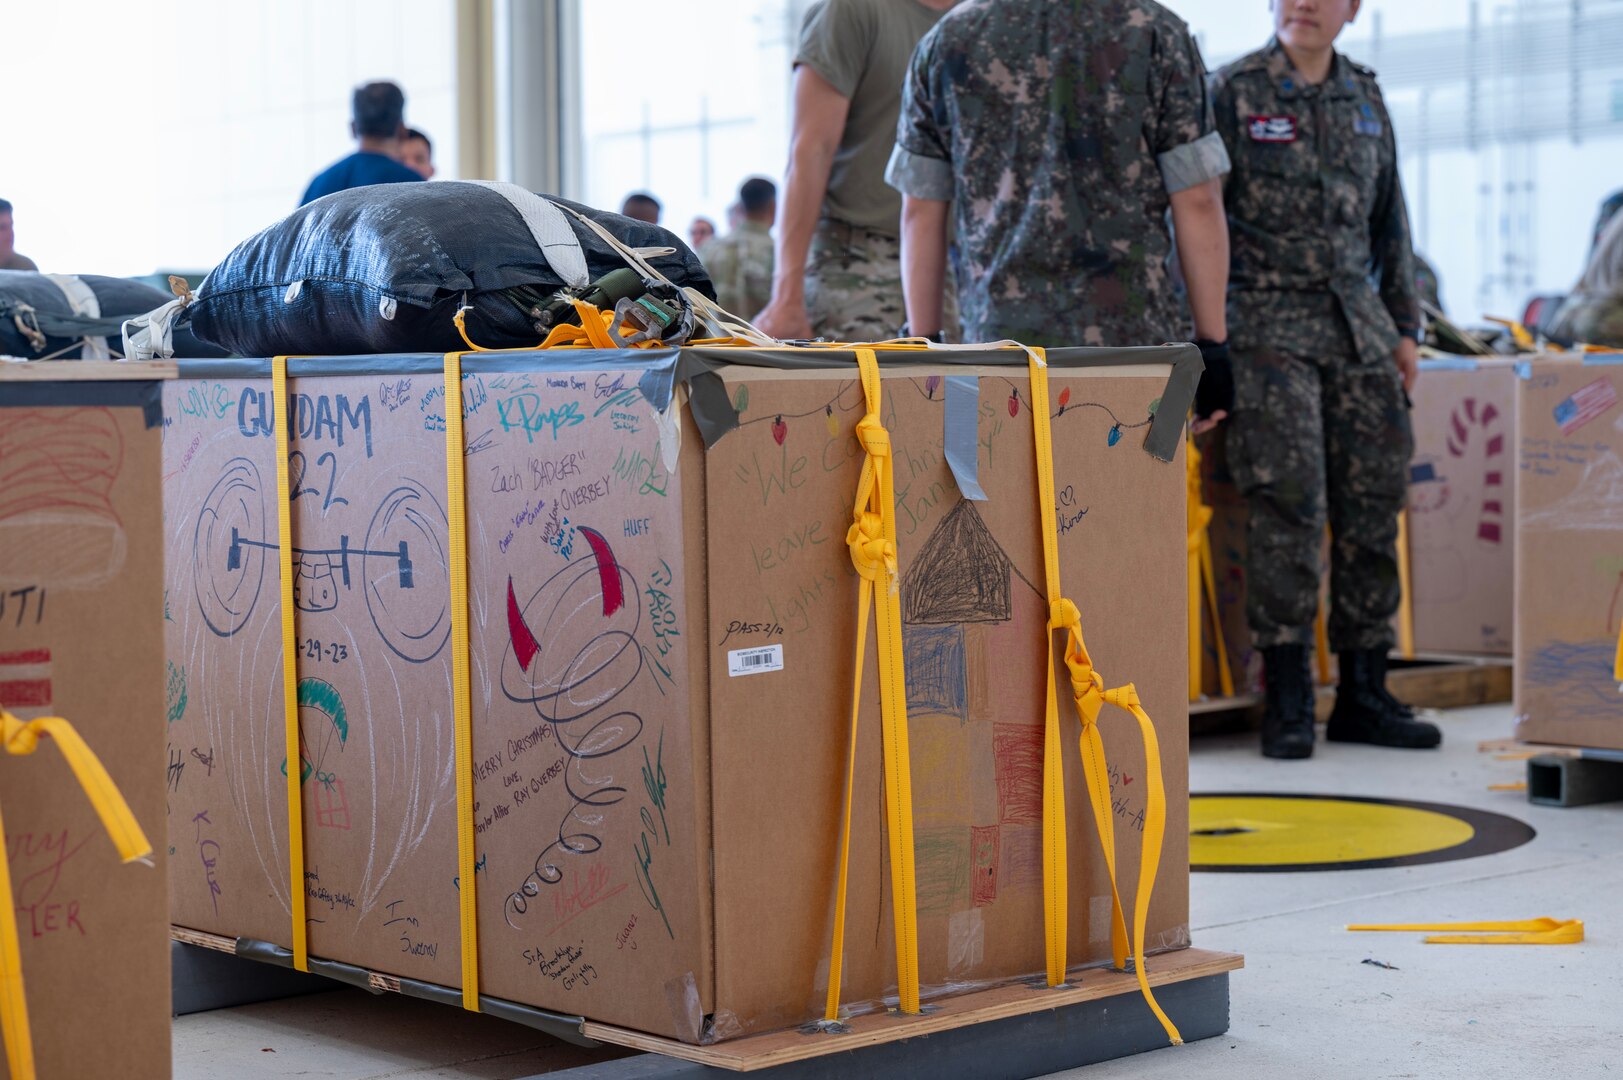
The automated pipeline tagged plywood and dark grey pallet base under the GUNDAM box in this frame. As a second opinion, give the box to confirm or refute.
[172,927,1245,1080]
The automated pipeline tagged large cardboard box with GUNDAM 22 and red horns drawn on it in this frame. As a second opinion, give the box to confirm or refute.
[166,348,1193,1041]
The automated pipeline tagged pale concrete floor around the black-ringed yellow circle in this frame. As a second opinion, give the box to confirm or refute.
[174,705,1623,1080]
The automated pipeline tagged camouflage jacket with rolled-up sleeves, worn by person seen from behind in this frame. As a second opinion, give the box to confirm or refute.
[886,0,1229,346]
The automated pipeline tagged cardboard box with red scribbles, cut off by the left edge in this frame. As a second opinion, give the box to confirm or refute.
[0,362,173,1080]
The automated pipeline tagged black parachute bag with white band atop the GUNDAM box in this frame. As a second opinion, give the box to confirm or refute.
[182,180,716,356]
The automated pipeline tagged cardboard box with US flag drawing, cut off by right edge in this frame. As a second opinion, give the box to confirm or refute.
[1516,356,1623,750]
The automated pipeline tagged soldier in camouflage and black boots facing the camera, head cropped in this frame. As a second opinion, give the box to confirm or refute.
[1212,0,1441,758]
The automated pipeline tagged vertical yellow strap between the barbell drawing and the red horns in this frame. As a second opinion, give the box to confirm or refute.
[445,352,479,1012]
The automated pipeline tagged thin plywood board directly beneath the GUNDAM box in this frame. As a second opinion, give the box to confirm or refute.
[584,948,1245,1072]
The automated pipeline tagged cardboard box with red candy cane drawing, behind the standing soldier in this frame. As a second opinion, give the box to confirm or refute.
[1409,357,1516,656]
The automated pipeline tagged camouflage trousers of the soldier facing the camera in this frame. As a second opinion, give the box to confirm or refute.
[1224,323,1414,651]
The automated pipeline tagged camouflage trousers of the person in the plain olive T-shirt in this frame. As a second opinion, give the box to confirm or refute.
[807,218,959,341]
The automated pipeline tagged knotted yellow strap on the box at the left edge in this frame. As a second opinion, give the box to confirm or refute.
[0,710,153,1080]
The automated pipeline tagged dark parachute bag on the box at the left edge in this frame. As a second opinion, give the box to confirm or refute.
[0,270,224,361]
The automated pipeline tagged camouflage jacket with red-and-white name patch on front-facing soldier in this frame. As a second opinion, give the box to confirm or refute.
[1212,39,1420,362]
